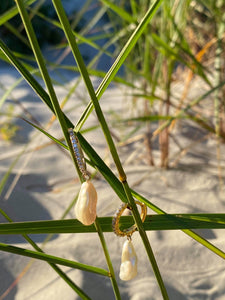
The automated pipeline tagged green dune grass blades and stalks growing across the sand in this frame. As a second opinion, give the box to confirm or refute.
[0,0,225,299]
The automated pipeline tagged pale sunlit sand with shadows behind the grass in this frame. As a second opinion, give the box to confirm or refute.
[0,68,225,300]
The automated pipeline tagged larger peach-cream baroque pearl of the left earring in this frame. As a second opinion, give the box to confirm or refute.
[75,180,97,225]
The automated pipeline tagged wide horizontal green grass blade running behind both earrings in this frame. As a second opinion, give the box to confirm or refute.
[0,214,225,234]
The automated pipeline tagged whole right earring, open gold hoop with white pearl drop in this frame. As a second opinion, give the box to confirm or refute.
[112,201,147,281]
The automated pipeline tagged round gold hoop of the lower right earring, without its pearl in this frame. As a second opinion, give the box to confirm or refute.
[112,201,147,237]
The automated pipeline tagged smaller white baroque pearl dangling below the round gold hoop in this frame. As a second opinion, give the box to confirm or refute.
[119,240,137,281]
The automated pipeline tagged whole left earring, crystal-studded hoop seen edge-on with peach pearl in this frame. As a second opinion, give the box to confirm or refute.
[68,128,98,225]
